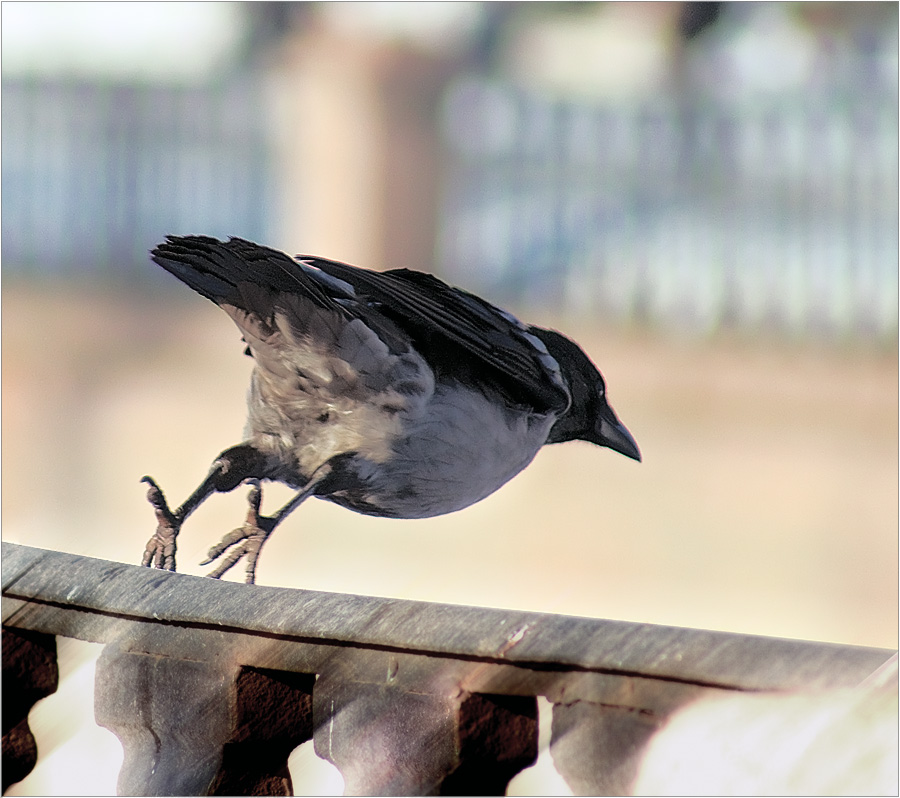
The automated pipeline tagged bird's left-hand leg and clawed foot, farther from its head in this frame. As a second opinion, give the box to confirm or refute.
[141,444,264,571]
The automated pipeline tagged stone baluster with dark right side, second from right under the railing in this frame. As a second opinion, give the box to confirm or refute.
[313,675,537,795]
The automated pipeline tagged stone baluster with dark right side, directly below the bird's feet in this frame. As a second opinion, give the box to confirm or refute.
[95,645,314,795]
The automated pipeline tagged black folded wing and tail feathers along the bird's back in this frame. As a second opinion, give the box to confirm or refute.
[152,236,570,412]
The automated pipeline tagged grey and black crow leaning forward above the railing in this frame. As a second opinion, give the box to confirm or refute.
[141,235,641,584]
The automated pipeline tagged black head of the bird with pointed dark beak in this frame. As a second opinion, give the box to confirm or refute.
[531,327,641,461]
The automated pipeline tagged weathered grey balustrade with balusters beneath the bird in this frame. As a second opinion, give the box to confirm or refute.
[2,543,892,795]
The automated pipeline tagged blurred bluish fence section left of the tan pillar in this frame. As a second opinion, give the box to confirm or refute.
[2,78,272,279]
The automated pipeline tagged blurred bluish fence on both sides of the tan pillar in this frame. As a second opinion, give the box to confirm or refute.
[2,74,898,339]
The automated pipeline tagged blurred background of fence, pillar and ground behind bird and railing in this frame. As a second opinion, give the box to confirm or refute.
[0,2,898,795]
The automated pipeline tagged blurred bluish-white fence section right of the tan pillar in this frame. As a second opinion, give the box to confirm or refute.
[439,79,898,337]
